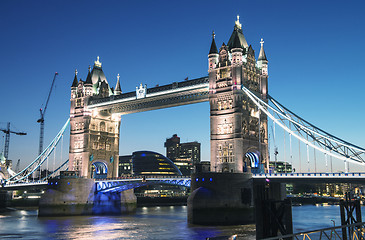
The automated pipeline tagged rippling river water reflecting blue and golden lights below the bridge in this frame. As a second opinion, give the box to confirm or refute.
[0,205,358,240]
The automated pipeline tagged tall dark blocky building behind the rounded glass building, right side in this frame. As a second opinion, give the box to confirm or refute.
[165,134,200,176]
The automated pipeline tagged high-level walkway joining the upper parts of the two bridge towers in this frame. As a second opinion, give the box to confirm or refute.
[88,77,209,115]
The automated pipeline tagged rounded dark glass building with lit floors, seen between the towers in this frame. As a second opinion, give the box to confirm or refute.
[132,151,182,175]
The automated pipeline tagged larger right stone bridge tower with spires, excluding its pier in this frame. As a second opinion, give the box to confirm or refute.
[208,16,268,173]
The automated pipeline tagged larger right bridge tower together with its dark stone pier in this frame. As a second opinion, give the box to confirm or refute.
[187,17,268,225]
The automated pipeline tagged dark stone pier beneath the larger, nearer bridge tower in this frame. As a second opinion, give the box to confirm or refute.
[188,172,254,225]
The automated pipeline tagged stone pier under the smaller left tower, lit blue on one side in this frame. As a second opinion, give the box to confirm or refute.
[38,178,137,216]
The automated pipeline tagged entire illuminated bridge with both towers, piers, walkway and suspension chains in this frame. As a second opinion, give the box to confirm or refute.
[1,16,365,229]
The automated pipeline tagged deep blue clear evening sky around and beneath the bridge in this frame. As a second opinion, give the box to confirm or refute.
[0,0,365,172]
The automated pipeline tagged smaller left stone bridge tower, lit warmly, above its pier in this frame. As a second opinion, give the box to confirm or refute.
[69,57,121,178]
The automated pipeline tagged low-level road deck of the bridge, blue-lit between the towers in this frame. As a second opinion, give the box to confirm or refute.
[4,173,365,192]
